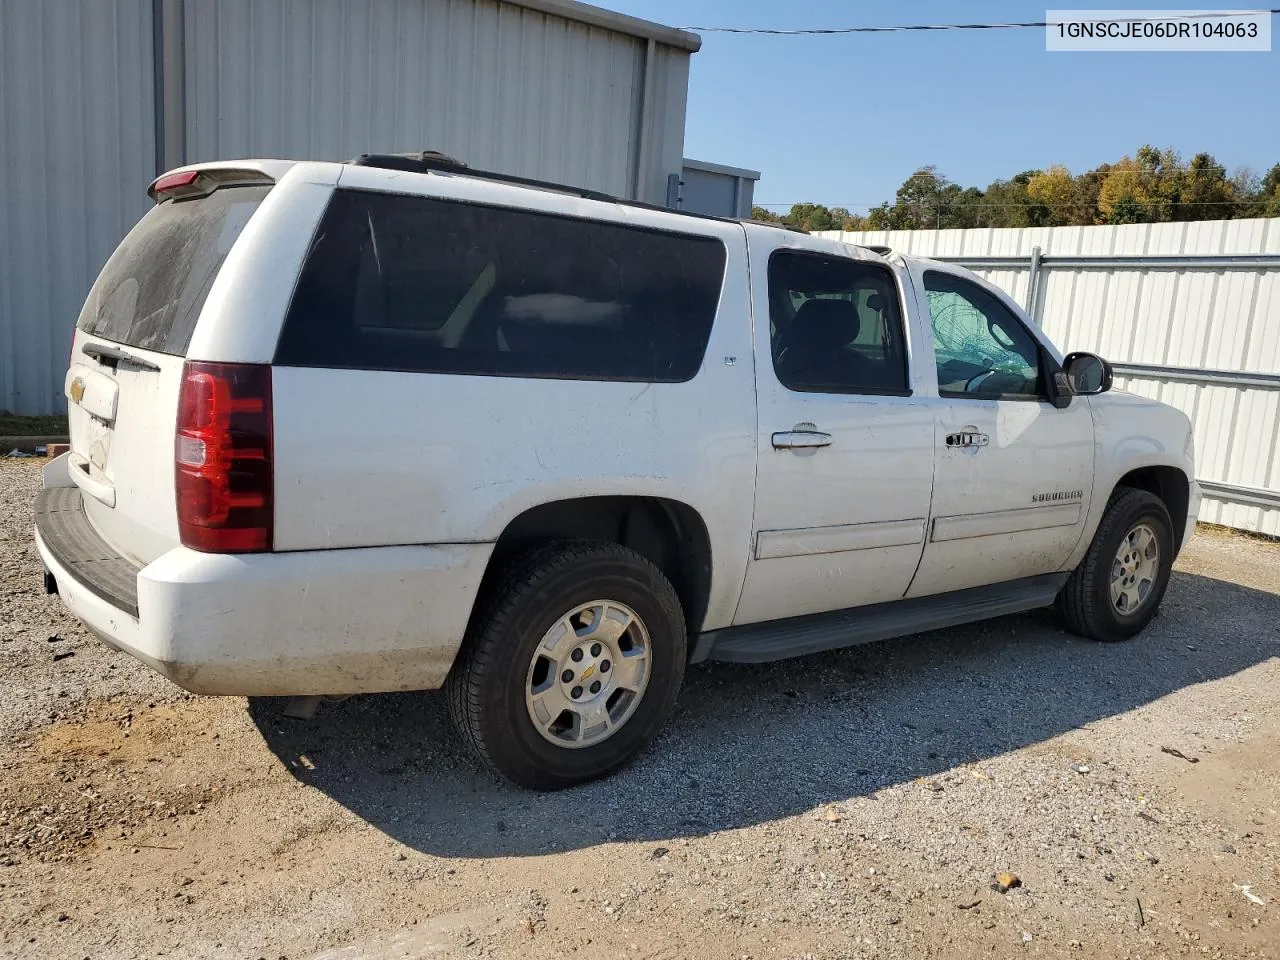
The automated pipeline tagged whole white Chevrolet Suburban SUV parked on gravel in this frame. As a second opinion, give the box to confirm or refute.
[36,154,1199,788]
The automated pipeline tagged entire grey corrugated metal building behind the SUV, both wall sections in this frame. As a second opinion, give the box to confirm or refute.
[0,0,699,413]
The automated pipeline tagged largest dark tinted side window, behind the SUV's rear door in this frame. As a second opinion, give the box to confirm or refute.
[275,191,726,383]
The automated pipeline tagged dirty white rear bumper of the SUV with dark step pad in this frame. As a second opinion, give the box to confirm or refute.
[36,490,493,696]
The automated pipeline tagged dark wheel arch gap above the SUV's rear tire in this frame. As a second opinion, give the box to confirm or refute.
[476,495,712,636]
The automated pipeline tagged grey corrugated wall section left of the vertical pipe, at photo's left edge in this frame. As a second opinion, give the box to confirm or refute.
[0,0,155,413]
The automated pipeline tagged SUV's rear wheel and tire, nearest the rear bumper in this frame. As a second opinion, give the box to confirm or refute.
[445,540,686,790]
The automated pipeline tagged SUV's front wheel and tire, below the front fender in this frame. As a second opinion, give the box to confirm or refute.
[1057,486,1174,641]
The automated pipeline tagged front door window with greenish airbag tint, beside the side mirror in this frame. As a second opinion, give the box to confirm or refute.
[924,270,1046,401]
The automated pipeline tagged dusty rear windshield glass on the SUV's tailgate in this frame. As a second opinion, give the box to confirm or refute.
[77,186,270,356]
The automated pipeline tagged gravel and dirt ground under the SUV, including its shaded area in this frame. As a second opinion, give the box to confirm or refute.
[0,461,1280,960]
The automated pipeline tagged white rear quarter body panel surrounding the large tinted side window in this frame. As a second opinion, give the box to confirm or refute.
[266,168,755,627]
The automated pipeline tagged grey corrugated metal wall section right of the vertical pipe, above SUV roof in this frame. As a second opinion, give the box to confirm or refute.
[180,0,690,204]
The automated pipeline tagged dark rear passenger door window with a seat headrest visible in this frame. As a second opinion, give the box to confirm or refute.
[769,251,909,394]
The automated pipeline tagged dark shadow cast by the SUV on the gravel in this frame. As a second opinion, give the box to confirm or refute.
[250,573,1280,858]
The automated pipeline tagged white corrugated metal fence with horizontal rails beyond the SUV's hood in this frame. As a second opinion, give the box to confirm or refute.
[823,219,1280,536]
